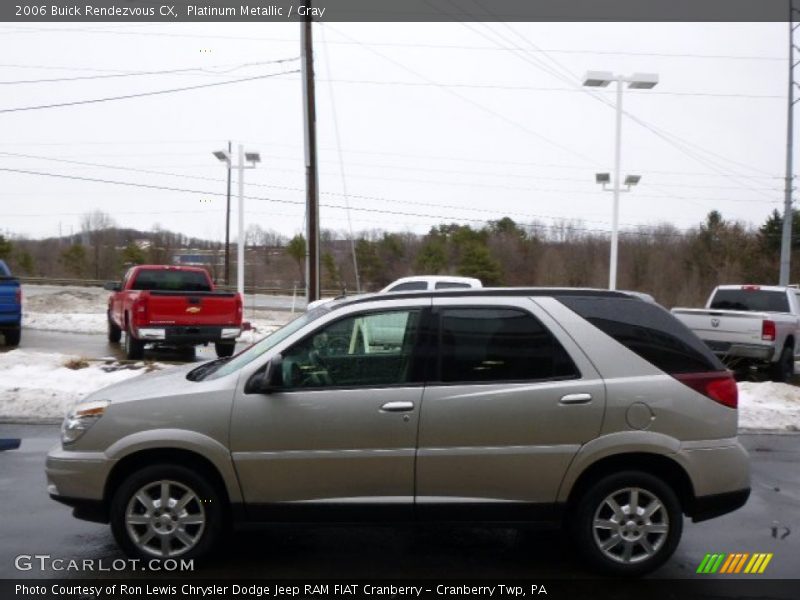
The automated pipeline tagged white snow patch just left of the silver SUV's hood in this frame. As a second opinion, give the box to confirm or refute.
[0,350,169,421]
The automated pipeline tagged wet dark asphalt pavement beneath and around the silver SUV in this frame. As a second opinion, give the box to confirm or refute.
[0,424,800,579]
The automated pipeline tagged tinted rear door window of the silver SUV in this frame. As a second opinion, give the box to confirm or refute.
[437,307,580,383]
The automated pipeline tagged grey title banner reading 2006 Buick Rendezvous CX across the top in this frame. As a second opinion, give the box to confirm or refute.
[0,0,790,23]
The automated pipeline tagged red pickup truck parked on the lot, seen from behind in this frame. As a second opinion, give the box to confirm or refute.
[105,265,242,359]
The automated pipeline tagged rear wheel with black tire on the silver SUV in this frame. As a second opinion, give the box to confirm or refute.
[567,471,683,577]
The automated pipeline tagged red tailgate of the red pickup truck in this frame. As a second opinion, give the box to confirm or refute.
[145,291,242,326]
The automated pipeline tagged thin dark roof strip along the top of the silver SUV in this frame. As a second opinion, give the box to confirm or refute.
[328,287,639,306]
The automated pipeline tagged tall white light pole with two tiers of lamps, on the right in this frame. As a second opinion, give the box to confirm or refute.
[583,71,658,290]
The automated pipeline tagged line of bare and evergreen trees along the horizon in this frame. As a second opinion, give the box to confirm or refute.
[0,211,800,306]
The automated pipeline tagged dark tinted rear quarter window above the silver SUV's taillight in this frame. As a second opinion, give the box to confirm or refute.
[557,296,725,374]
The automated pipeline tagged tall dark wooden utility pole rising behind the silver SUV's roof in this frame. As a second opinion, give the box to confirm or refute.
[300,17,320,302]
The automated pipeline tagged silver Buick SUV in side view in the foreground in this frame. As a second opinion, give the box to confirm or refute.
[47,289,750,575]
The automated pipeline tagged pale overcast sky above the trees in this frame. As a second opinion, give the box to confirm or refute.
[0,23,787,240]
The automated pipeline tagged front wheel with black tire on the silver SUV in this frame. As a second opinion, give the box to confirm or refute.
[109,464,225,560]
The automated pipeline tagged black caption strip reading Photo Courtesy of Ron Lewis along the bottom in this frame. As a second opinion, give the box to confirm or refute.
[0,576,800,600]
